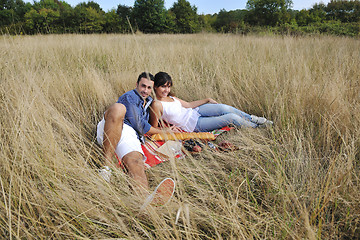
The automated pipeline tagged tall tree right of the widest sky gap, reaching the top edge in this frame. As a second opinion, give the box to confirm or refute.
[246,0,292,26]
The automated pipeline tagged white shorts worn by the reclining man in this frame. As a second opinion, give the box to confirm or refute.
[96,118,146,161]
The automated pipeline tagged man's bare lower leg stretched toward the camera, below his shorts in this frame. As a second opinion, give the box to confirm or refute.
[122,151,149,196]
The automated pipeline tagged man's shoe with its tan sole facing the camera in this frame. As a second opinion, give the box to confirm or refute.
[140,178,175,210]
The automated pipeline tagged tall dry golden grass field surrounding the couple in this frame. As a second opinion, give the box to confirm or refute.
[0,34,360,239]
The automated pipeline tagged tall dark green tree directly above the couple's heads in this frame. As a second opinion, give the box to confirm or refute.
[132,0,168,33]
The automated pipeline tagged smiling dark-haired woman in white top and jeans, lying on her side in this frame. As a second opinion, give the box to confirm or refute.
[149,72,273,132]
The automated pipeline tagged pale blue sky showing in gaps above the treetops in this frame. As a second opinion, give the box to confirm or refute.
[27,0,330,14]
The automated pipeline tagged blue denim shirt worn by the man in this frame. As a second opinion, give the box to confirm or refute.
[117,89,153,140]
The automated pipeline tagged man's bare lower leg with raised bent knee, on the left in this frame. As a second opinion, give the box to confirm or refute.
[103,103,126,166]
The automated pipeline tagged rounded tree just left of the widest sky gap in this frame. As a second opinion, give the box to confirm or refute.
[170,0,200,33]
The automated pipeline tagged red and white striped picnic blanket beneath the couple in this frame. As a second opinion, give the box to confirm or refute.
[141,127,232,168]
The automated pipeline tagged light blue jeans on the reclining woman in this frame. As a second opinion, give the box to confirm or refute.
[194,103,258,132]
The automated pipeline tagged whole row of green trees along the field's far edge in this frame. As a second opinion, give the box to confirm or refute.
[0,0,360,36]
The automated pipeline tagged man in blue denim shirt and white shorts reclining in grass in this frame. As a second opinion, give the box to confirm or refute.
[97,72,175,207]
